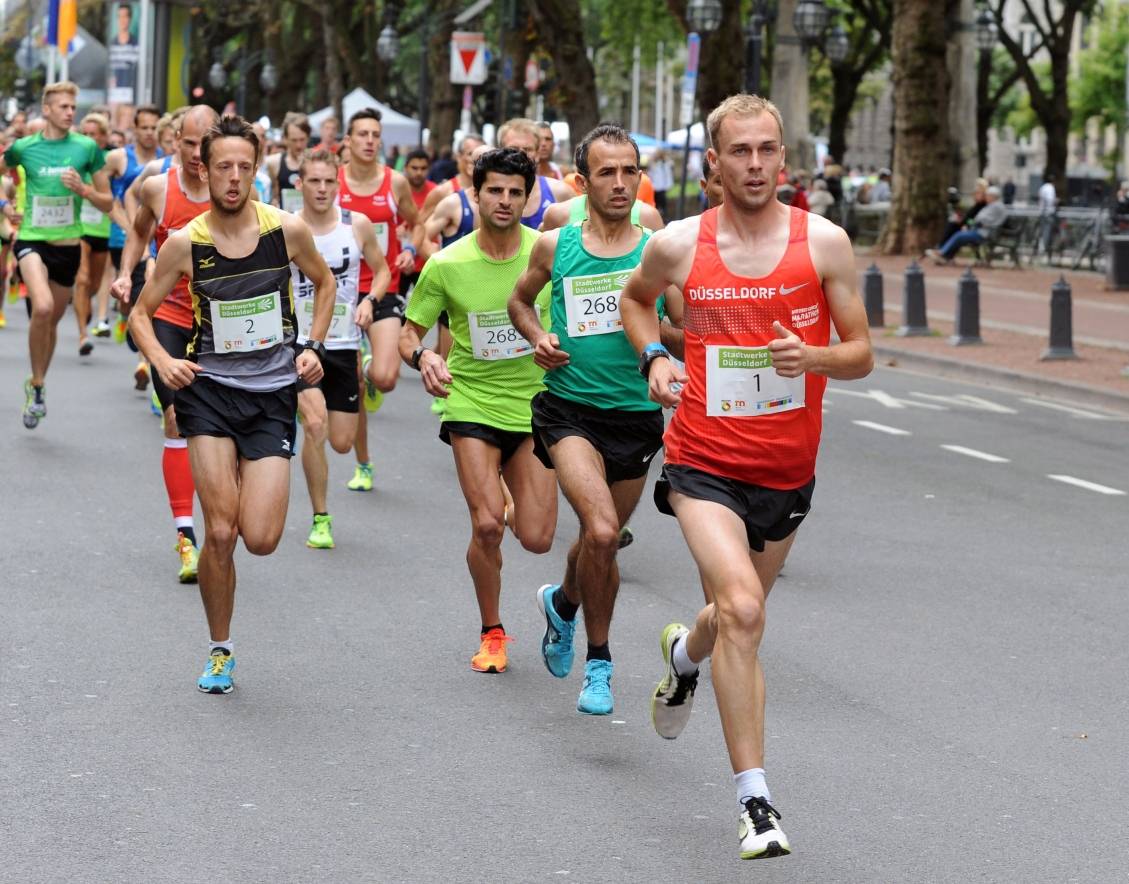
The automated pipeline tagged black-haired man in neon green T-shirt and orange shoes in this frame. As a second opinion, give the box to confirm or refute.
[400,149,557,673]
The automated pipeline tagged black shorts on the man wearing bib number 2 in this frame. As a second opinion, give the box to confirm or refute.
[175,376,298,461]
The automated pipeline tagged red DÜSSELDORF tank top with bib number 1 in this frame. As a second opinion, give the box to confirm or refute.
[665,209,831,489]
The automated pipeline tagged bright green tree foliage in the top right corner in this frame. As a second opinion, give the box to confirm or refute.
[1070,3,1129,132]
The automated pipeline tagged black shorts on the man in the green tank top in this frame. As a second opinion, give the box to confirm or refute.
[533,392,663,484]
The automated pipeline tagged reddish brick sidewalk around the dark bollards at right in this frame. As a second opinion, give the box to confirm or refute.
[856,253,1129,413]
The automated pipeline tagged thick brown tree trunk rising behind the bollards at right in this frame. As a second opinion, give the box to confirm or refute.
[882,0,949,254]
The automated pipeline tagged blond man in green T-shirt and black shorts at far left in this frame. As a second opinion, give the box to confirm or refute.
[0,81,113,430]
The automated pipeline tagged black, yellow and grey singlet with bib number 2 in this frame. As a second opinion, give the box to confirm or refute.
[189,202,297,392]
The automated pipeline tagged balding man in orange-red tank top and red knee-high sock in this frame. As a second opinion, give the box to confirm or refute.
[111,105,219,584]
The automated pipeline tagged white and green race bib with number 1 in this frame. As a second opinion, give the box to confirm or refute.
[706,345,806,418]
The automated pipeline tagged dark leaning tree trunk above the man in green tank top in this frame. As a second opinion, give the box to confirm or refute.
[528,0,599,145]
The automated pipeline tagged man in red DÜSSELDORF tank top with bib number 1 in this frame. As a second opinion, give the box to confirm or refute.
[621,95,874,859]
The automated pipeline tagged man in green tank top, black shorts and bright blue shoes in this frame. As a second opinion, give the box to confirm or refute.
[509,125,663,715]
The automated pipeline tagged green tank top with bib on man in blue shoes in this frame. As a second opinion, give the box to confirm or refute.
[545,224,658,411]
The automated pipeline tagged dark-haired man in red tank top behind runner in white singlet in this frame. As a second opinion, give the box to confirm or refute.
[338,107,419,491]
